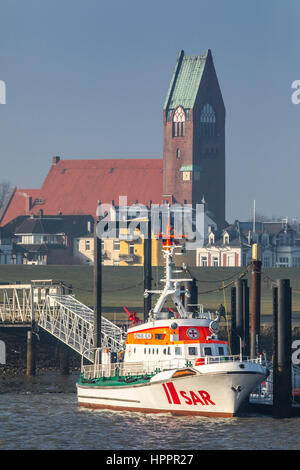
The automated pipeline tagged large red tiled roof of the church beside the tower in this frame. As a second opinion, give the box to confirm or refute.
[0,159,163,226]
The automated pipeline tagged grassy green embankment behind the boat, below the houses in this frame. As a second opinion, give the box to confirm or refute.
[0,265,300,320]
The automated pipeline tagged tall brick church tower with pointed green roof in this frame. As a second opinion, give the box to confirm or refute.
[163,50,225,229]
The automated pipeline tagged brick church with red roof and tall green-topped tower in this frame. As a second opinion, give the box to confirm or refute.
[0,50,225,229]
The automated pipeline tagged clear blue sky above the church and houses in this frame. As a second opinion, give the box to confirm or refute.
[0,0,300,222]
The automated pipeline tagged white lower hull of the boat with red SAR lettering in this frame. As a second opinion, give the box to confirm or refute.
[77,368,266,417]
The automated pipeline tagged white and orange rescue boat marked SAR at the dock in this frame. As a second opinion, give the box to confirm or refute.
[77,226,268,417]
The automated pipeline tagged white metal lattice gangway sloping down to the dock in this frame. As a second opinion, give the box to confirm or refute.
[0,280,126,362]
